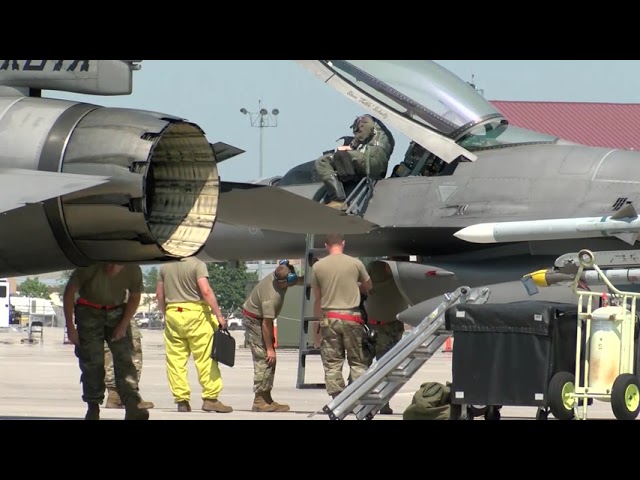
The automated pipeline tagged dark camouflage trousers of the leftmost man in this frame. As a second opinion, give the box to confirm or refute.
[75,305,141,406]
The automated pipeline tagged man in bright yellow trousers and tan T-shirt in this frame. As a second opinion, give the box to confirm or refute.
[156,257,233,413]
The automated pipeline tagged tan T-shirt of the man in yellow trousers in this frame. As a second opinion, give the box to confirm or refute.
[158,257,209,304]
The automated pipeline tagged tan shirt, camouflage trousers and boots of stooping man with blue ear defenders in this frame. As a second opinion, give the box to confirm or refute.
[242,268,298,412]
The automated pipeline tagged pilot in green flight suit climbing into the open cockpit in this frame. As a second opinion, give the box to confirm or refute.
[315,115,395,208]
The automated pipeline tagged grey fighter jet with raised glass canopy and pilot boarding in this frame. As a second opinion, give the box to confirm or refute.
[200,60,640,316]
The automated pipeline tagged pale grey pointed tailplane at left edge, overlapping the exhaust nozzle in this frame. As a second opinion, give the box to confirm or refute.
[0,168,109,213]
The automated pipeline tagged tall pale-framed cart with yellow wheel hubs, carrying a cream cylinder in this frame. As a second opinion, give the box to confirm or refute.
[549,250,640,420]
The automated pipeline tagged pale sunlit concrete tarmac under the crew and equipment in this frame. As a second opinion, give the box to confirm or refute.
[0,327,614,420]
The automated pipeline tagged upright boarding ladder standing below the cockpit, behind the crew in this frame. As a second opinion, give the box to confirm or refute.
[296,234,325,389]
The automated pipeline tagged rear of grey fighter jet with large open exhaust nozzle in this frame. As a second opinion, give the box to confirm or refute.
[0,60,373,277]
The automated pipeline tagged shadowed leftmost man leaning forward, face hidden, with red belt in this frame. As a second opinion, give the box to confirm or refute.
[63,263,149,420]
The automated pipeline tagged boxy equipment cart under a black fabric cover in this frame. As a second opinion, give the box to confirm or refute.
[445,301,580,420]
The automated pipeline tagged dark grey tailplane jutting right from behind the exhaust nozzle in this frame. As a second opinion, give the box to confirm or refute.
[218,182,378,235]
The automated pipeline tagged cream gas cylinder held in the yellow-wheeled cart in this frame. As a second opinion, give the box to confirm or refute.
[589,306,629,393]
